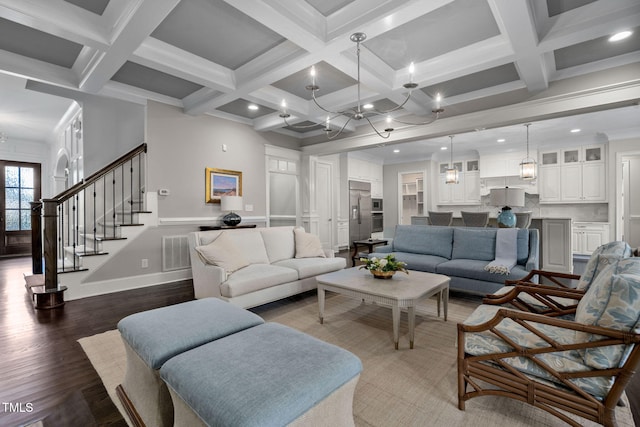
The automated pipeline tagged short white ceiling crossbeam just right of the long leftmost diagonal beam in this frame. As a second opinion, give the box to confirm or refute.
[131,37,235,91]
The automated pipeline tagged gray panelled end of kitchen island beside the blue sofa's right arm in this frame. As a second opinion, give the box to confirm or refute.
[541,218,573,274]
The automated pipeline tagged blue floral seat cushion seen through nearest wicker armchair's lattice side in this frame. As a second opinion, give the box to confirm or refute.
[464,304,613,398]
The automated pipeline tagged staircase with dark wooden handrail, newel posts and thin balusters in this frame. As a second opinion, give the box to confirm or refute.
[25,144,152,309]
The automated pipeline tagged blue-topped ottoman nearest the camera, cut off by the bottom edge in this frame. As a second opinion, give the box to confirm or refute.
[160,323,362,427]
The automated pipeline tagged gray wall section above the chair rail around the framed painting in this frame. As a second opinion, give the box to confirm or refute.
[147,102,288,218]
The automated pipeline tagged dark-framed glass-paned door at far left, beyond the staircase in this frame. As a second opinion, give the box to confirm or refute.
[0,160,41,256]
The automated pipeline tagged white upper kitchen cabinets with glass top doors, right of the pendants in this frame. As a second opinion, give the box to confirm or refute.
[539,145,607,203]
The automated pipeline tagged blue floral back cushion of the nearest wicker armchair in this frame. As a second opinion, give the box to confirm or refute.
[576,258,640,369]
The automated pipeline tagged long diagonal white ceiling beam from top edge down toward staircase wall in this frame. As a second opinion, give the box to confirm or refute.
[80,0,180,93]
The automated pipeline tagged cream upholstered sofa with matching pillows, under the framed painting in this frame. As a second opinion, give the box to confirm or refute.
[189,227,346,308]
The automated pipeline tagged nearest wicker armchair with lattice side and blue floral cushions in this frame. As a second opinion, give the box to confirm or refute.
[458,258,640,426]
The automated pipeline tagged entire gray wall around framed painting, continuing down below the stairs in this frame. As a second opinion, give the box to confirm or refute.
[87,102,291,281]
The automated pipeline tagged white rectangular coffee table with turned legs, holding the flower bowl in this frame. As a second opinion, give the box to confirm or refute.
[316,267,450,350]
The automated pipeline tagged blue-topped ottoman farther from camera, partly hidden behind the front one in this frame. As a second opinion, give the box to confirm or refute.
[117,298,264,427]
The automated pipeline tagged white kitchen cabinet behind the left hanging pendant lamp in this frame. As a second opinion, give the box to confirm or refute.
[438,159,480,205]
